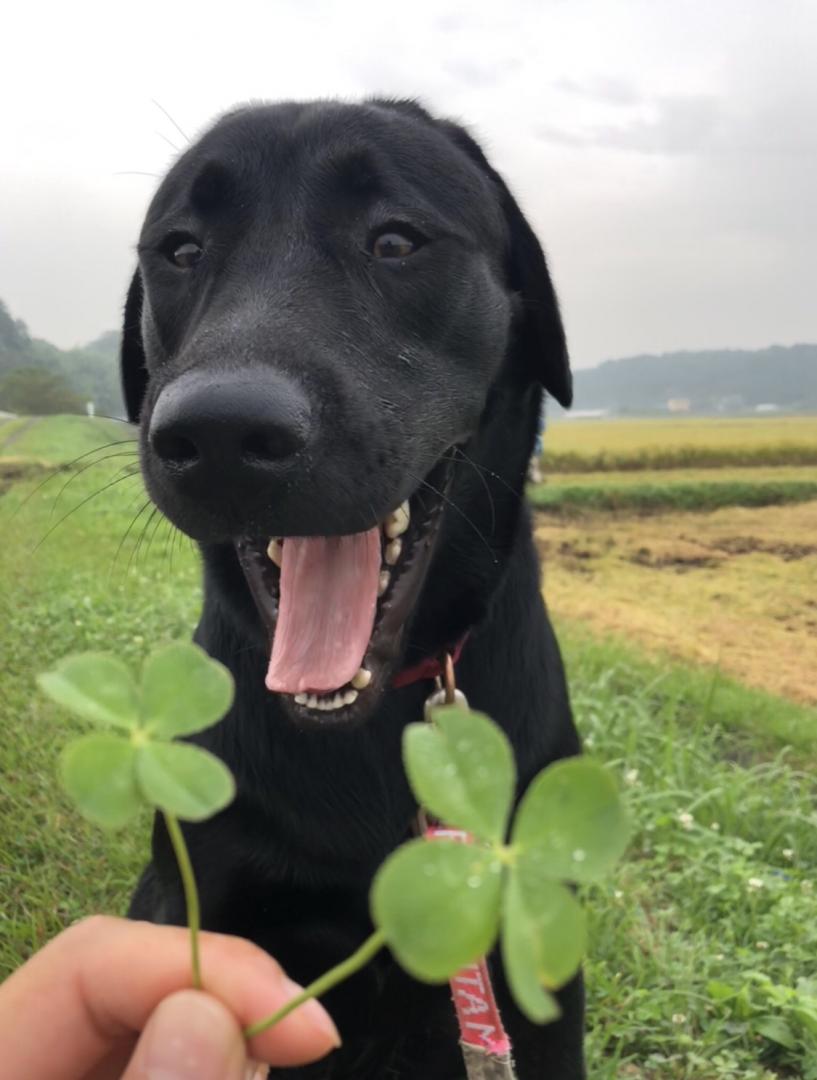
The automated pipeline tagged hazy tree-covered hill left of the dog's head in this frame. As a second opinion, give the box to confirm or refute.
[0,300,124,416]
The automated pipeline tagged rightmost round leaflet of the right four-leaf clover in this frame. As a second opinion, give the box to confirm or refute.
[511,757,629,882]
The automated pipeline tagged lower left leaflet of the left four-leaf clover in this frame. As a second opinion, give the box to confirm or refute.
[59,734,142,828]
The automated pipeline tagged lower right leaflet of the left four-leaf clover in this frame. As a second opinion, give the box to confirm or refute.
[136,741,236,821]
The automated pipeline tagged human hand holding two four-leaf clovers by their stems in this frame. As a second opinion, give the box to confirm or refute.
[0,916,340,1080]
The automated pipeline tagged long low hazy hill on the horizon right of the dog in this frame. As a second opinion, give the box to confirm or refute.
[573,345,817,413]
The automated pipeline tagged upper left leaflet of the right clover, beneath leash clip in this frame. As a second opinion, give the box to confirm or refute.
[403,705,515,843]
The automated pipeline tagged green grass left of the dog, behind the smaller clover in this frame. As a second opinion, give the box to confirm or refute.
[0,436,199,977]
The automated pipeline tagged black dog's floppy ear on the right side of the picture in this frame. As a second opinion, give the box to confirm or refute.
[441,121,573,408]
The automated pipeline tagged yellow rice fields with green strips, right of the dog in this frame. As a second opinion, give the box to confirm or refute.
[530,417,817,706]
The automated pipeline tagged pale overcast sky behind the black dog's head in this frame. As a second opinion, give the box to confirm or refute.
[0,0,817,366]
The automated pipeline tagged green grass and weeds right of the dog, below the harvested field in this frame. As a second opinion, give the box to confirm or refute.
[560,626,817,1080]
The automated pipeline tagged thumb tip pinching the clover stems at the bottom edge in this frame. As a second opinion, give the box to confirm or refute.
[122,990,246,1080]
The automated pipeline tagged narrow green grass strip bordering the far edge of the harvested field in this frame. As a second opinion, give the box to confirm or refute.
[527,480,817,514]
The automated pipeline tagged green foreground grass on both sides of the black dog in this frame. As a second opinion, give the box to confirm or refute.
[0,416,817,1080]
